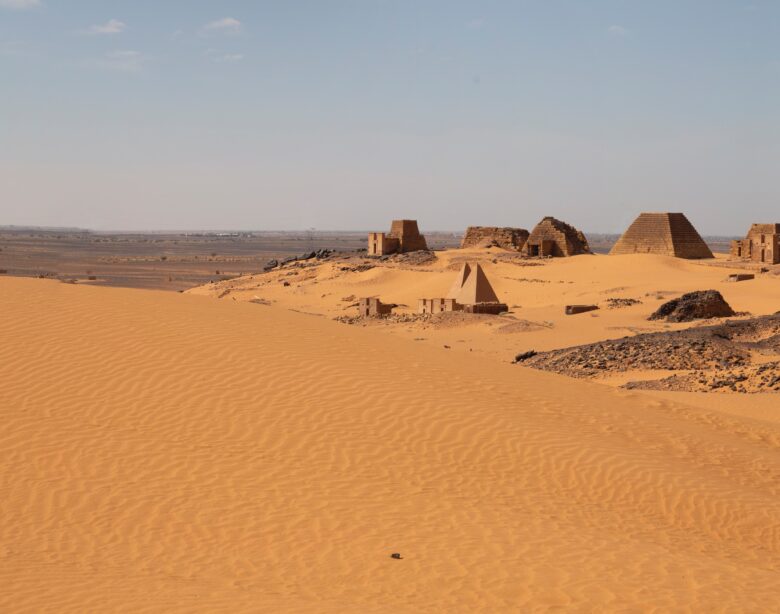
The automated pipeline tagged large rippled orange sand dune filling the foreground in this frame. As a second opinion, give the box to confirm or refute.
[0,279,780,612]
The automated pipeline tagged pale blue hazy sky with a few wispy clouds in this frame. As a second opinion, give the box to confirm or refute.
[0,0,780,235]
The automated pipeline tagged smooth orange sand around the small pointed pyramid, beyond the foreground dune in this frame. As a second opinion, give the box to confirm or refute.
[188,249,780,361]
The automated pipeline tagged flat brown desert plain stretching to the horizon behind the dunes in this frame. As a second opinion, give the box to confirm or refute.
[0,228,458,290]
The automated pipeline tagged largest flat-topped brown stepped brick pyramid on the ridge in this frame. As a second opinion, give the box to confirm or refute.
[609,213,713,258]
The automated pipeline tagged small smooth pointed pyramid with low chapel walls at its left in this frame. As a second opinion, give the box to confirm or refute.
[417,263,508,314]
